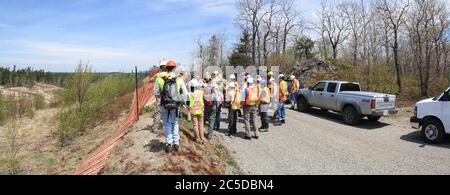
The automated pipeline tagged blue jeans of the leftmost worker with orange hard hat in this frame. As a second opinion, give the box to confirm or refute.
[161,109,180,145]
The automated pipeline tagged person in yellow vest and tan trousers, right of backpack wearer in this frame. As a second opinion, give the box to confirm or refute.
[188,79,206,144]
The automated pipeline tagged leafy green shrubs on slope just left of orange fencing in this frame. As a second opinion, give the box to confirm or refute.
[57,71,134,146]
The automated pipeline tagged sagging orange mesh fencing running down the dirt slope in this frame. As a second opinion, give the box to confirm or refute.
[74,69,162,175]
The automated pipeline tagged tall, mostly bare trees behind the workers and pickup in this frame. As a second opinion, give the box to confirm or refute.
[194,0,450,97]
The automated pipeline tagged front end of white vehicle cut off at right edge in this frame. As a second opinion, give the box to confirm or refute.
[411,88,450,144]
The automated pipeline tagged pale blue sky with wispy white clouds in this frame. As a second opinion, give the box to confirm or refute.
[0,0,318,72]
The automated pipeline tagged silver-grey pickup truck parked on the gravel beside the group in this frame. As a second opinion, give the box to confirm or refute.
[297,81,398,125]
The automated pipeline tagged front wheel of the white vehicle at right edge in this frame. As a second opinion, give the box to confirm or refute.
[422,119,445,144]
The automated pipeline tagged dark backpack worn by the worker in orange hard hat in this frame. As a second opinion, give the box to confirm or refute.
[161,78,181,111]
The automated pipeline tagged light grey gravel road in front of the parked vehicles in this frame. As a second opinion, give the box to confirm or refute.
[220,110,450,175]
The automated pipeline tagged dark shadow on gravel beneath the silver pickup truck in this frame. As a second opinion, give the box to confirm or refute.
[295,109,390,130]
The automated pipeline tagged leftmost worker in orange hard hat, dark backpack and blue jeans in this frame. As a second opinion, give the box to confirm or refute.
[154,60,187,153]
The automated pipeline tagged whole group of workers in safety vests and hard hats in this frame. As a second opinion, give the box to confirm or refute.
[154,60,300,153]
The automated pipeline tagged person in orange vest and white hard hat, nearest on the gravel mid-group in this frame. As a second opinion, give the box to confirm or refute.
[242,77,259,140]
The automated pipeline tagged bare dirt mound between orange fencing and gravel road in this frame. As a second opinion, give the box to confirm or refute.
[104,111,240,175]
